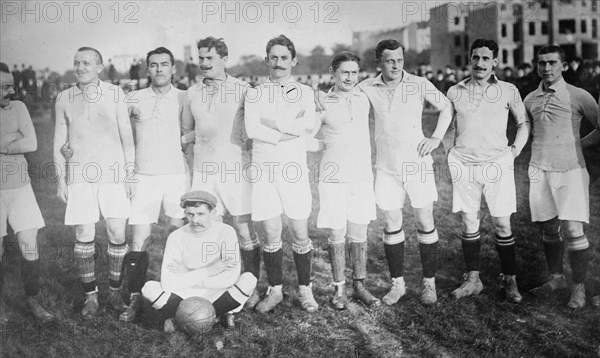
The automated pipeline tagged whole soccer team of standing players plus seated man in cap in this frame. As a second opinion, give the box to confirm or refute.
[0,35,600,331]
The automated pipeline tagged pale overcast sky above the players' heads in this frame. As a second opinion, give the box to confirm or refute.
[0,0,446,72]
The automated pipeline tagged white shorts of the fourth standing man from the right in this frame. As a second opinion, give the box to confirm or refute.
[317,182,377,229]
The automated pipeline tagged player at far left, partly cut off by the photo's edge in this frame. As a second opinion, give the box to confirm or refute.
[0,63,54,324]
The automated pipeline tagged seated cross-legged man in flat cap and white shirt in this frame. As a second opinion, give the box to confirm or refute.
[142,190,256,332]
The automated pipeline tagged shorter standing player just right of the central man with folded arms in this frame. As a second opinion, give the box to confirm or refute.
[317,52,381,310]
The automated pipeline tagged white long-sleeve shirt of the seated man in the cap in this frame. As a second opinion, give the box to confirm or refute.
[160,222,241,302]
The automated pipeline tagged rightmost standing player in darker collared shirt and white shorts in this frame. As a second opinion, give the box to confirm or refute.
[524,45,600,310]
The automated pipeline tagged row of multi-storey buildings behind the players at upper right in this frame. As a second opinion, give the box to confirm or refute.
[352,0,600,70]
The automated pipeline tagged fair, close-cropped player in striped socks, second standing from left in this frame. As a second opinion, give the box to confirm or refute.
[54,47,135,319]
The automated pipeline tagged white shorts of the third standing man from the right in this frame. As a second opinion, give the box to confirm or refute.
[375,168,438,211]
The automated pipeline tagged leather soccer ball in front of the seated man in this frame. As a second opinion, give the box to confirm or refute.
[175,296,216,337]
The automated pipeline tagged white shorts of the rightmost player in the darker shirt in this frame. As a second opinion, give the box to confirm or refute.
[528,166,590,223]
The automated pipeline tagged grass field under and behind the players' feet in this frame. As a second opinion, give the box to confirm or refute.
[1,106,600,357]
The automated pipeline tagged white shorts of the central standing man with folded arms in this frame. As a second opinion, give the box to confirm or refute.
[250,167,312,221]
